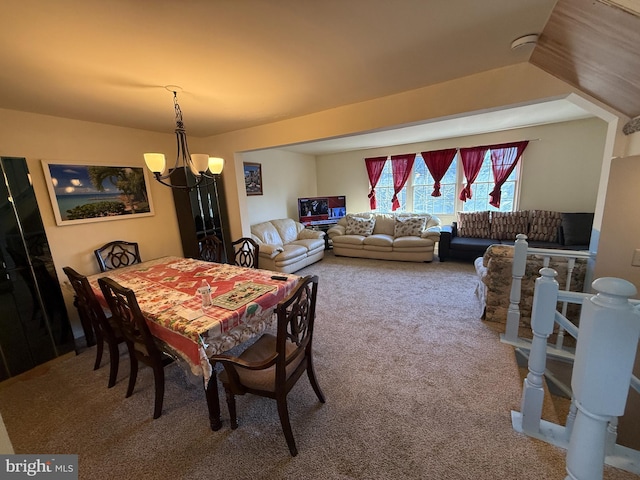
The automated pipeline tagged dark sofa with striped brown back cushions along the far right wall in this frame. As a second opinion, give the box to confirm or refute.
[438,210,593,262]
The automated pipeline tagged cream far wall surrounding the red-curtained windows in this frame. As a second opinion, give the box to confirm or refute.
[317,119,606,223]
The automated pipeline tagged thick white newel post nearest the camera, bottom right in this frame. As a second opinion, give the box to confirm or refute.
[565,277,640,480]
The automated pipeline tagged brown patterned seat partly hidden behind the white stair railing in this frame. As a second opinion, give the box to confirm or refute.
[474,244,587,337]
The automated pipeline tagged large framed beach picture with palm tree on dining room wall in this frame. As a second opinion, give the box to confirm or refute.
[42,160,154,225]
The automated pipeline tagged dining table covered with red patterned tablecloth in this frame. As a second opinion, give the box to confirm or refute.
[87,256,300,430]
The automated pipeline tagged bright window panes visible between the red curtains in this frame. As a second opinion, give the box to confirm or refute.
[376,151,520,215]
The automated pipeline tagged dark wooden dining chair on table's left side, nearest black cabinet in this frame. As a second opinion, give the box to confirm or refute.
[62,267,124,388]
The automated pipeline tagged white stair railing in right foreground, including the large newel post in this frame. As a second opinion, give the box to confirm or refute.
[512,268,640,480]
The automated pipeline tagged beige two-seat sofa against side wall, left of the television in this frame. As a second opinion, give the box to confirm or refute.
[251,218,325,273]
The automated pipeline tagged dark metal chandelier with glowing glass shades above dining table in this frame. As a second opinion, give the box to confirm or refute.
[144,85,224,190]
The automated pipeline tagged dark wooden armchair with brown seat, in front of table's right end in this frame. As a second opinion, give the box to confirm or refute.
[211,276,325,457]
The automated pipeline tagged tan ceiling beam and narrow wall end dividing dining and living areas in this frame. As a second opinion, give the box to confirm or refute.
[200,63,596,236]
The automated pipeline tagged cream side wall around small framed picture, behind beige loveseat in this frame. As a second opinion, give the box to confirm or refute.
[242,150,324,225]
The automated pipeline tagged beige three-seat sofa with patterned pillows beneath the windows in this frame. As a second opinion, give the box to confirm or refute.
[327,212,440,262]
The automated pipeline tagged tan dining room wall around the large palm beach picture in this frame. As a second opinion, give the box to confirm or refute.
[0,109,182,336]
